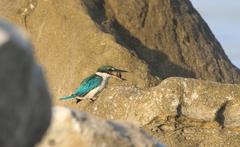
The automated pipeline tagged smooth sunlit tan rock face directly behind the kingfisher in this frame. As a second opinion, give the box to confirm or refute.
[0,0,157,105]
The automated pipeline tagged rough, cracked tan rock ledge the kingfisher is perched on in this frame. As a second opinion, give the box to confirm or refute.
[58,78,240,146]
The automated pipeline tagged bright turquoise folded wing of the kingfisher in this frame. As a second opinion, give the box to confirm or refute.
[74,74,103,97]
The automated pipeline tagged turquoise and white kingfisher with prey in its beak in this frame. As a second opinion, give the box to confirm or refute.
[60,65,127,103]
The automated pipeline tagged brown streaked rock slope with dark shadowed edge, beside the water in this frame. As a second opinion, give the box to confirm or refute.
[82,0,240,83]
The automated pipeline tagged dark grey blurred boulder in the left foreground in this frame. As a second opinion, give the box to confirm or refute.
[0,20,51,147]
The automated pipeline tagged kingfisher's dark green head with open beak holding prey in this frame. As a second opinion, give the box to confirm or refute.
[97,65,127,80]
